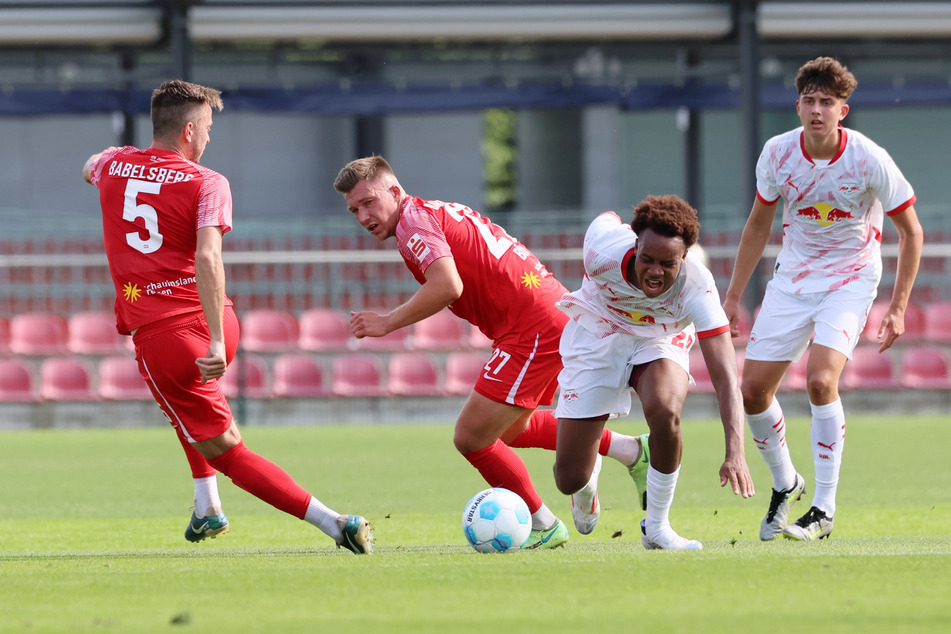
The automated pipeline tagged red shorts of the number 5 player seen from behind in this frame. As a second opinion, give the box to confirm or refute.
[132,306,239,442]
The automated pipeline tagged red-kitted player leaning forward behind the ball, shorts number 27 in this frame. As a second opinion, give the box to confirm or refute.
[334,156,647,548]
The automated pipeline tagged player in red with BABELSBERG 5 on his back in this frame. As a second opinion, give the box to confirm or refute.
[83,80,374,554]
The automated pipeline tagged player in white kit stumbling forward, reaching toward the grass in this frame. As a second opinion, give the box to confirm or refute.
[555,196,755,550]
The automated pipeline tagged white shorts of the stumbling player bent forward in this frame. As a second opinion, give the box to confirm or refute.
[555,321,697,419]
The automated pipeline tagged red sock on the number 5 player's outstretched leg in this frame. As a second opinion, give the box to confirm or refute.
[208,441,311,519]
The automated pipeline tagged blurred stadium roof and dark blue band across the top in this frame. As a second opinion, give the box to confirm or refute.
[0,0,951,116]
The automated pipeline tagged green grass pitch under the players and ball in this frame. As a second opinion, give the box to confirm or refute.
[0,417,951,634]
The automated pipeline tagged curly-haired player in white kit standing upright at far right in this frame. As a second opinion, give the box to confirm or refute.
[723,57,922,541]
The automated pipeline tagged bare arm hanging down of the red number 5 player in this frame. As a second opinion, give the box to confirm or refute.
[195,227,228,383]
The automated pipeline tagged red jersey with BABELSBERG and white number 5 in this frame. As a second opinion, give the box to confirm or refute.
[92,146,231,334]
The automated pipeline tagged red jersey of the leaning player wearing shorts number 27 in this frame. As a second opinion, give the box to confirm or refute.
[396,196,566,341]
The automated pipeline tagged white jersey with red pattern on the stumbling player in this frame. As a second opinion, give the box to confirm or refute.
[558,212,730,339]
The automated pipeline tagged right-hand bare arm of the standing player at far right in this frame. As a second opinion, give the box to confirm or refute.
[878,205,924,352]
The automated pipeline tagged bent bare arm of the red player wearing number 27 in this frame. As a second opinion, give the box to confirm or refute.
[350,257,462,339]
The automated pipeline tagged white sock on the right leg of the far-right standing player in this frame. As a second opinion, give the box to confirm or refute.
[811,399,845,517]
